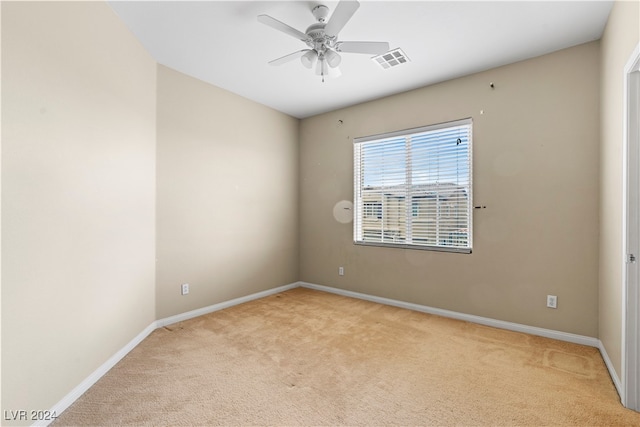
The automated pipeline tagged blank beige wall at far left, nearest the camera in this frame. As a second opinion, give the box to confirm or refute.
[2,2,156,424]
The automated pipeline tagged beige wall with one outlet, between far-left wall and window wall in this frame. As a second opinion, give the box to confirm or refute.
[156,66,298,318]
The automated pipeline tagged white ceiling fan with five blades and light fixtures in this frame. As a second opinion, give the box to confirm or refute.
[258,0,389,81]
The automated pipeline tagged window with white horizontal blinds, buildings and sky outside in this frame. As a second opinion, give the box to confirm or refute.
[353,119,472,253]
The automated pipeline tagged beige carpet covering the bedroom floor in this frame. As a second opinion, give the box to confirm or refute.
[55,288,640,426]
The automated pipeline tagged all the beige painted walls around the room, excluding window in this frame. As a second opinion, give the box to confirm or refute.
[1,2,639,422]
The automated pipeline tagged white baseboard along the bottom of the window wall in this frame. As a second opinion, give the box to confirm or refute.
[299,282,600,348]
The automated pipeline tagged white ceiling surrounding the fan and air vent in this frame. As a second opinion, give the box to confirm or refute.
[110,0,613,118]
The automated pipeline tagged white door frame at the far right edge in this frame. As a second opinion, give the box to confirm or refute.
[621,44,640,411]
